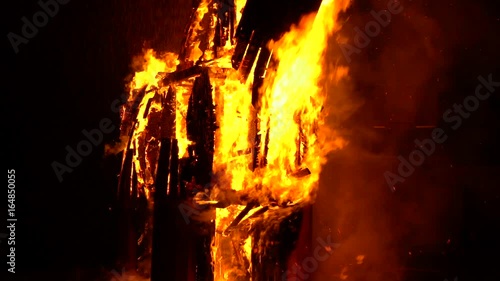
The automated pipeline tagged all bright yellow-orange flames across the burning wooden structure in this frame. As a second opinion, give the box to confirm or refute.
[119,0,349,281]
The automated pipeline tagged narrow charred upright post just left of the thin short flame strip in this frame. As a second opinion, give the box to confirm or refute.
[151,75,188,281]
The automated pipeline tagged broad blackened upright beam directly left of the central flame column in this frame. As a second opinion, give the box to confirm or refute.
[172,66,216,281]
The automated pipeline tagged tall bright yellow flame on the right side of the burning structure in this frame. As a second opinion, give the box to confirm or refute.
[260,0,348,201]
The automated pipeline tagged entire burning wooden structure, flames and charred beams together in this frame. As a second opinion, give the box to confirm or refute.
[112,0,349,281]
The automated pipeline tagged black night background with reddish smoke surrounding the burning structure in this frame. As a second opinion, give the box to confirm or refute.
[0,0,500,281]
